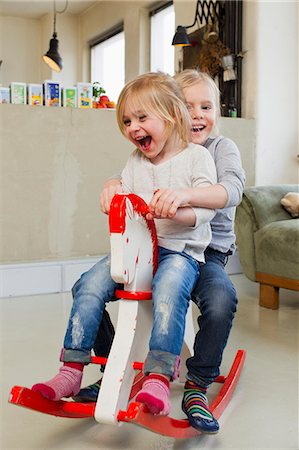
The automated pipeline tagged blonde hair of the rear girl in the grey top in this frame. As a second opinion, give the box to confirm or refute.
[174,69,220,117]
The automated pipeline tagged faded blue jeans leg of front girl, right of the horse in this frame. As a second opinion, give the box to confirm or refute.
[143,247,199,378]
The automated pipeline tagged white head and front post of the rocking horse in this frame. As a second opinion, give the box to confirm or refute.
[95,194,156,424]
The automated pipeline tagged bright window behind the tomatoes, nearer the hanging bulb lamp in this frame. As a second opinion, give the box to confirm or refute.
[91,30,125,102]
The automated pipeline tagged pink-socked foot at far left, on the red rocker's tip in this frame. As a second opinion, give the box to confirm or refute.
[31,366,83,401]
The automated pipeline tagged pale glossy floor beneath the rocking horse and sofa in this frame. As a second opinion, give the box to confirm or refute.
[0,275,299,450]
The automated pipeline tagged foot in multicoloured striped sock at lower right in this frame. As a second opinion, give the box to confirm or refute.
[182,381,219,434]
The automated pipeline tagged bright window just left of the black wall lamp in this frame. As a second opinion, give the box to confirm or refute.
[151,2,175,75]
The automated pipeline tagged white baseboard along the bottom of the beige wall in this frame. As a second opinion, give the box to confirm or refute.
[0,252,242,298]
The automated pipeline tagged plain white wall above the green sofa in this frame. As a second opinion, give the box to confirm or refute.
[255,1,298,185]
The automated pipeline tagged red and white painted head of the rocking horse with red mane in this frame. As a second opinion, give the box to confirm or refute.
[109,194,158,291]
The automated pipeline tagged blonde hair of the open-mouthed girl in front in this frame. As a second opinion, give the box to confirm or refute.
[116,72,191,145]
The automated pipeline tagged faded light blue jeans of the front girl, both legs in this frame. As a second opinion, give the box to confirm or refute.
[61,247,199,377]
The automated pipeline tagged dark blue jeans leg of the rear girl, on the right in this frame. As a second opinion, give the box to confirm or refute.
[186,247,238,387]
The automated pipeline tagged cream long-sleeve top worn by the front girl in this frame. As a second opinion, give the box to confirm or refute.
[121,143,217,262]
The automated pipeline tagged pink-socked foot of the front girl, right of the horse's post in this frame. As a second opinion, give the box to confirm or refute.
[136,375,170,416]
